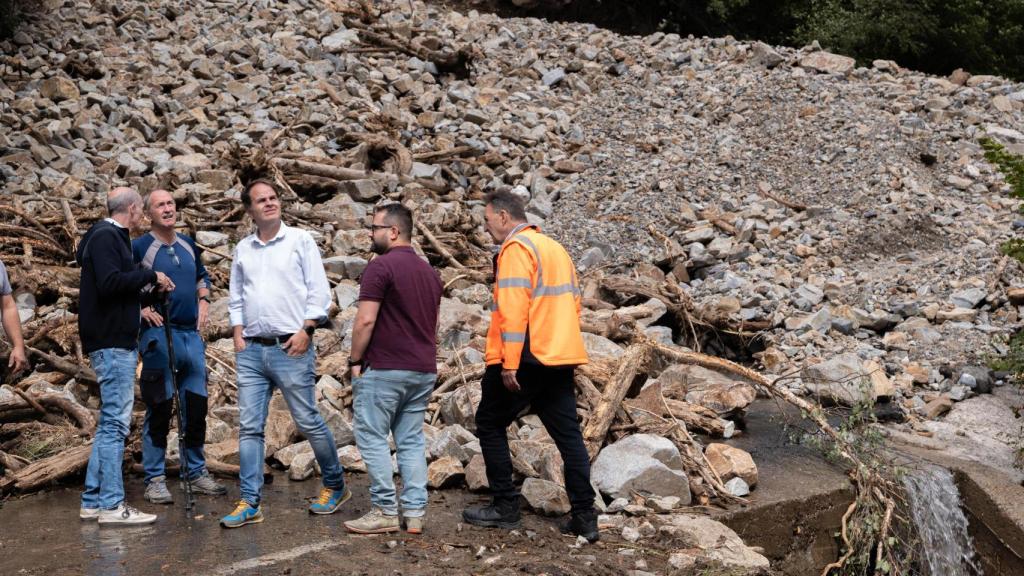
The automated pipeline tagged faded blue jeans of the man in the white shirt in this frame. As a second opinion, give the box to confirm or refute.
[234,340,345,506]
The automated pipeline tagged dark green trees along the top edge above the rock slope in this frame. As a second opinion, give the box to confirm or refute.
[546,0,1024,80]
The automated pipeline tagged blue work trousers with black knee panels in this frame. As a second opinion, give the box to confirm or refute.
[138,326,207,484]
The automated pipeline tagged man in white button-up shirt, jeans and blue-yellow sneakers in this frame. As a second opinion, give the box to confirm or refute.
[220,180,351,528]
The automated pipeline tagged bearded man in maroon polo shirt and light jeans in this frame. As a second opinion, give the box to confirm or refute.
[345,204,442,534]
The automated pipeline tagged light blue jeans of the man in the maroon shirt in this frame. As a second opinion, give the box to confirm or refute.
[352,369,437,518]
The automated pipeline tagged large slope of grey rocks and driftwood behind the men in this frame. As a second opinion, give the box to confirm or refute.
[0,0,1024,564]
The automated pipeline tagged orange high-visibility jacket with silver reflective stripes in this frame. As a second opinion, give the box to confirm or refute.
[485,225,587,370]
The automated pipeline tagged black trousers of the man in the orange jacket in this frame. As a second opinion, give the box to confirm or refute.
[476,364,594,513]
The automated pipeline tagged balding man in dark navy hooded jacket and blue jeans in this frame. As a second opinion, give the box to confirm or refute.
[75,188,174,525]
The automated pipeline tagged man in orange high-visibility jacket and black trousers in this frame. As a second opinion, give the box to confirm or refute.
[462,192,598,542]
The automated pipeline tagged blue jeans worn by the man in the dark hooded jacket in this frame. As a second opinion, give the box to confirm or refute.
[82,348,138,509]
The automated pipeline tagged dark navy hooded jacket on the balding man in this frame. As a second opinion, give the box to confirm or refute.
[75,219,157,354]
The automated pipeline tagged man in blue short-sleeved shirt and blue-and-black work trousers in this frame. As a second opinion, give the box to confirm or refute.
[132,190,227,504]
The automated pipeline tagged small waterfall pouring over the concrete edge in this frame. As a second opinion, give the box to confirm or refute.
[903,466,983,576]
